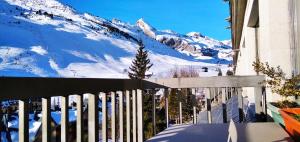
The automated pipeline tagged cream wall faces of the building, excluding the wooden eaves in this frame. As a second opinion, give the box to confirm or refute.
[236,0,293,102]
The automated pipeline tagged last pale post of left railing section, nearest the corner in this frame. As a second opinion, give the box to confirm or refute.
[137,89,144,142]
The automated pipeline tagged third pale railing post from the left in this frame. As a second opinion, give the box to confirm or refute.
[60,96,69,142]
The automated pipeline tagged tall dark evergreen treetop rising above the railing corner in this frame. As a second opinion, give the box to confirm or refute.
[128,41,153,79]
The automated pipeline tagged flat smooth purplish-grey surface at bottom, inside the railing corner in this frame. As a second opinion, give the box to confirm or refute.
[147,123,293,142]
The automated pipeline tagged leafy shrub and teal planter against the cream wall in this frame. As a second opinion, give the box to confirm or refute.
[252,60,300,126]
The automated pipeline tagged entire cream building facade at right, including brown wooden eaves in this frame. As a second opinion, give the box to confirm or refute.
[229,0,300,102]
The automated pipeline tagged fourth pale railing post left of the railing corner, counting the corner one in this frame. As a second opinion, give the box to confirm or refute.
[117,91,124,142]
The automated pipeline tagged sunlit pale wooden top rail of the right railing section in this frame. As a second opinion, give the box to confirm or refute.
[148,75,265,88]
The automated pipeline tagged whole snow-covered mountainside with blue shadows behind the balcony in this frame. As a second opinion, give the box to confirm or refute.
[0,0,232,78]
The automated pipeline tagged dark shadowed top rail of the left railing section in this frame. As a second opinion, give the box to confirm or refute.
[0,77,165,99]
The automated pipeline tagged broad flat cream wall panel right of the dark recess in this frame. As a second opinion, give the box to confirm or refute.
[259,0,293,76]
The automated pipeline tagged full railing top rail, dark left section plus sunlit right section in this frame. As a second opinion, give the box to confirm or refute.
[0,76,265,99]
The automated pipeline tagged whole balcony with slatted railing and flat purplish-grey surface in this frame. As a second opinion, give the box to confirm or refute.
[0,76,291,142]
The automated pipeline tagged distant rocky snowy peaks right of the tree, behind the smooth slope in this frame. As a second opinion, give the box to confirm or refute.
[137,19,231,60]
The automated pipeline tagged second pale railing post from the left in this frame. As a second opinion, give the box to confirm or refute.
[42,98,51,142]
